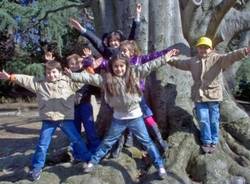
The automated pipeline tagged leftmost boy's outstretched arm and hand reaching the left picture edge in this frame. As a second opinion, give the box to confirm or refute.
[0,70,37,93]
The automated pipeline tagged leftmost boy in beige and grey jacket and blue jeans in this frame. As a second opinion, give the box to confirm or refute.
[0,61,91,180]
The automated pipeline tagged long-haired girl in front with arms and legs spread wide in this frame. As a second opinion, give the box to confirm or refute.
[66,51,178,178]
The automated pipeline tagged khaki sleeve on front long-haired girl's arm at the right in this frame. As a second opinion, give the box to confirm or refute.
[134,54,172,78]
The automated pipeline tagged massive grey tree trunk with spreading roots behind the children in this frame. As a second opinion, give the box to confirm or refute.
[92,0,250,183]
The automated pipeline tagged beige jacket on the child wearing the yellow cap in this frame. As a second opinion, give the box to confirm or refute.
[169,49,247,102]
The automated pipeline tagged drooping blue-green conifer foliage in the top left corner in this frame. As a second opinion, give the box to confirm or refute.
[0,0,90,55]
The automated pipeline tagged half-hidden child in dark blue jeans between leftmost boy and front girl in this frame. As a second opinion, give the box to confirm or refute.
[66,54,100,154]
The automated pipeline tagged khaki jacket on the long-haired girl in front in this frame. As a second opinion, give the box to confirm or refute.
[71,55,168,113]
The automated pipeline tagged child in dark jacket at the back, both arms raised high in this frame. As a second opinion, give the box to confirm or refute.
[70,4,141,59]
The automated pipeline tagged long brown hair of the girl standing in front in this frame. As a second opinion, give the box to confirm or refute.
[104,53,142,96]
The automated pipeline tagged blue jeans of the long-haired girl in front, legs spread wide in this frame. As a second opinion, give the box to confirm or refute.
[90,117,163,168]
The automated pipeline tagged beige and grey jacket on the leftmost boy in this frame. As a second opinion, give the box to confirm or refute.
[15,75,83,121]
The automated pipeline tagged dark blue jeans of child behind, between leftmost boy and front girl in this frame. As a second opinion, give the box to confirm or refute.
[73,103,101,152]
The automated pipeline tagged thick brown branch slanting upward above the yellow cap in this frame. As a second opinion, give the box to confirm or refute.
[206,0,237,39]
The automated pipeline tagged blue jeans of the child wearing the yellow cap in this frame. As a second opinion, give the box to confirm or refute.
[195,102,220,144]
